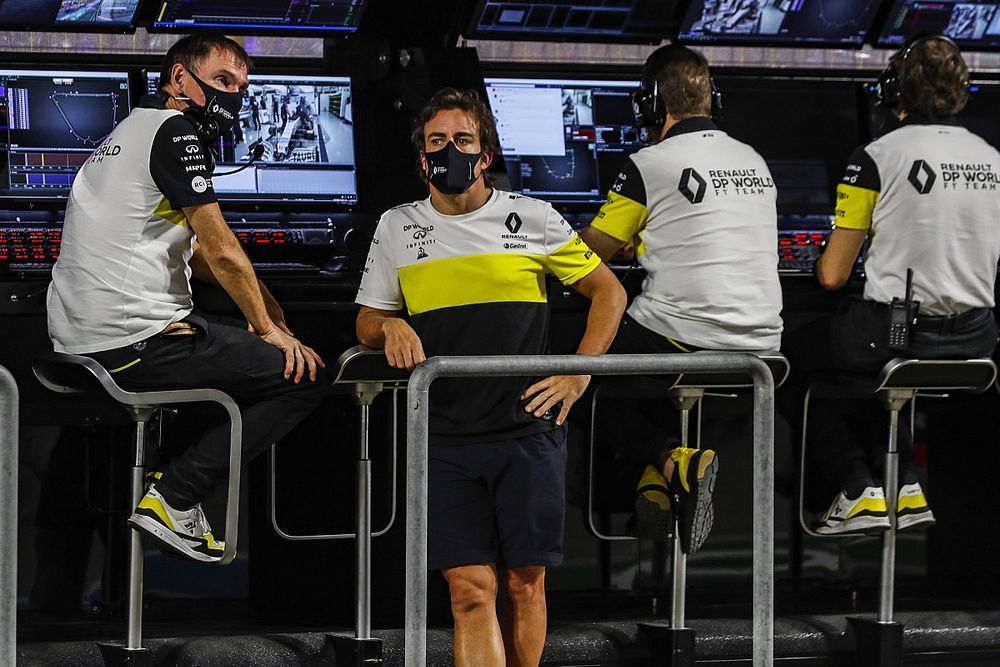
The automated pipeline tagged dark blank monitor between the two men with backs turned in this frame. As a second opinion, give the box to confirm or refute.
[716,76,866,214]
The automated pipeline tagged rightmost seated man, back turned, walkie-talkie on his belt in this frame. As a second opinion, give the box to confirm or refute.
[804,36,1000,534]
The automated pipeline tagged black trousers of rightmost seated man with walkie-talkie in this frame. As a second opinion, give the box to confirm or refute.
[779,297,997,510]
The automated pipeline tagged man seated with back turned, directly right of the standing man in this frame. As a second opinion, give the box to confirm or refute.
[582,45,782,553]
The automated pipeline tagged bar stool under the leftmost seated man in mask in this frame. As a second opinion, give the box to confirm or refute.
[32,352,243,666]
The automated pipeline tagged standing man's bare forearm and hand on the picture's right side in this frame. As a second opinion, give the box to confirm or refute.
[522,264,626,426]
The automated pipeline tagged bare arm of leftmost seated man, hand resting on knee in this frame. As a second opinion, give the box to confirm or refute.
[184,203,324,382]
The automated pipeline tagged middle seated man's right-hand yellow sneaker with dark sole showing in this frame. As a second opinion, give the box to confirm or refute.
[669,447,719,554]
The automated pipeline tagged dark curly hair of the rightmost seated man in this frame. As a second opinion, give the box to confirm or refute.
[894,38,969,120]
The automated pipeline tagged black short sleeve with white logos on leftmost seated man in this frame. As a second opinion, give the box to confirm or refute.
[149,115,218,209]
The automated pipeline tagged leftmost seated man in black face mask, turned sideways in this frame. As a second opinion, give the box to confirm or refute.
[47,32,323,562]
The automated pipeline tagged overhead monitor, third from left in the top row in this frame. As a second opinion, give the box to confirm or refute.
[465,0,674,44]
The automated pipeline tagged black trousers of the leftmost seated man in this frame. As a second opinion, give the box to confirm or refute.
[89,313,326,509]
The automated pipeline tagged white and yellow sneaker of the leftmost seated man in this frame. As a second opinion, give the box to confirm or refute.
[128,485,226,563]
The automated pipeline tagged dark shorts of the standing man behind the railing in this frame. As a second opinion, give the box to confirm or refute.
[427,428,566,570]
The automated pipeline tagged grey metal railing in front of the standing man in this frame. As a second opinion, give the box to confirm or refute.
[404,352,774,667]
